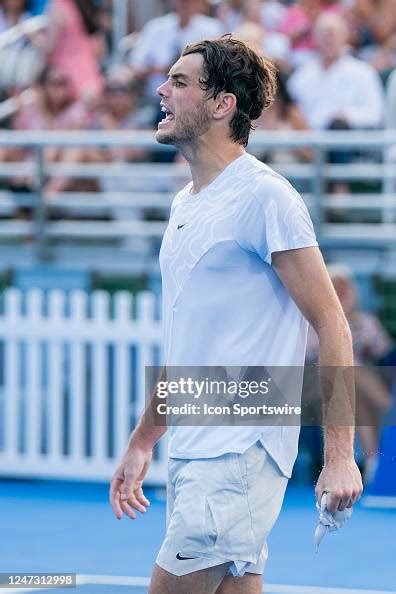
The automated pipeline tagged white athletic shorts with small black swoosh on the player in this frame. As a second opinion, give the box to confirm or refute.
[156,441,288,576]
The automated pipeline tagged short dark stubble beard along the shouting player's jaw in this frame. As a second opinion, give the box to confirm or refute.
[156,104,210,146]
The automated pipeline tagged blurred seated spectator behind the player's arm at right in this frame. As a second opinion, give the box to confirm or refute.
[307,264,392,483]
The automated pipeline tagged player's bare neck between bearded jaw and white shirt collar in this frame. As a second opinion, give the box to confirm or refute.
[180,140,246,194]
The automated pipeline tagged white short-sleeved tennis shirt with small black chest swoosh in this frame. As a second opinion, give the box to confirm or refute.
[160,153,318,476]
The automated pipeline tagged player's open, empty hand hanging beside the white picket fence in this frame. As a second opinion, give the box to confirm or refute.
[110,446,153,520]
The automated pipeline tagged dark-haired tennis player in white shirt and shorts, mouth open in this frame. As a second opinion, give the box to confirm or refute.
[110,35,362,594]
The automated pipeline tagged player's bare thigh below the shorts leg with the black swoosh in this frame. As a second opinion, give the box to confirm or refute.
[148,563,231,594]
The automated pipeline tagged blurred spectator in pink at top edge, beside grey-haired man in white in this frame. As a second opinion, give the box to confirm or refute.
[280,0,343,67]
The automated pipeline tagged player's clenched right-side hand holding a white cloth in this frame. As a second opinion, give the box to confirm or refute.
[315,458,363,512]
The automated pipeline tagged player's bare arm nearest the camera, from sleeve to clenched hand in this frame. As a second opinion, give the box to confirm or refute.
[271,247,363,511]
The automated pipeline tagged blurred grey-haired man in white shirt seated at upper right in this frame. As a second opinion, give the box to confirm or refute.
[288,14,384,129]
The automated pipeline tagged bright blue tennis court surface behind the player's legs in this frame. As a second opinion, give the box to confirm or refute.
[0,480,396,594]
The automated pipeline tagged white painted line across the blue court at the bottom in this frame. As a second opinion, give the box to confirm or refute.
[0,574,396,594]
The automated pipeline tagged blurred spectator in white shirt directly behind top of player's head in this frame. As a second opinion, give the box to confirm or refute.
[130,0,223,104]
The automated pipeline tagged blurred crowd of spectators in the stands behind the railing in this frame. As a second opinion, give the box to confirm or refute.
[0,0,396,191]
